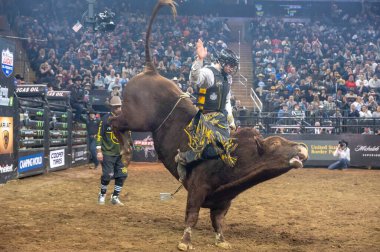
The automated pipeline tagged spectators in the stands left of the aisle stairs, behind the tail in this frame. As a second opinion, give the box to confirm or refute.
[11,1,228,119]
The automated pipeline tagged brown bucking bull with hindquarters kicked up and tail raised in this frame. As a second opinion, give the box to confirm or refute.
[112,0,308,250]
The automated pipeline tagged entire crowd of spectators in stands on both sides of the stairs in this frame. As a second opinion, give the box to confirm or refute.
[10,0,380,134]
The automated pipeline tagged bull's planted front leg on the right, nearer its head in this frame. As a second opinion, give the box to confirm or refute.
[210,201,231,249]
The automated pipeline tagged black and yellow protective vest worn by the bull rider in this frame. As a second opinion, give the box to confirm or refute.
[196,66,230,112]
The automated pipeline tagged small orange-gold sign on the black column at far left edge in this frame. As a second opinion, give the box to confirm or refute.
[0,117,13,154]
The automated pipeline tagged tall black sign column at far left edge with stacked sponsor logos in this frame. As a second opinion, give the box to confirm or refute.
[0,38,17,183]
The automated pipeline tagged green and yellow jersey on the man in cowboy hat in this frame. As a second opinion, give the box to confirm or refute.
[96,113,120,156]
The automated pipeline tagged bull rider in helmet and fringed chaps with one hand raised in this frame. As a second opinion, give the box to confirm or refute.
[175,39,239,182]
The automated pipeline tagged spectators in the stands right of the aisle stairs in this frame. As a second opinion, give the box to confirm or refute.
[250,1,380,134]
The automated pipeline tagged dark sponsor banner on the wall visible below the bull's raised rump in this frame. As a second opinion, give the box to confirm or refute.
[132,132,158,162]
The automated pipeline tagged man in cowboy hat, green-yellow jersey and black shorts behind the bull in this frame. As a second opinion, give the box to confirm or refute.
[96,96,131,205]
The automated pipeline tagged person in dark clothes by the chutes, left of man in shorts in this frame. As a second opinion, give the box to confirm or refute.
[87,109,101,169]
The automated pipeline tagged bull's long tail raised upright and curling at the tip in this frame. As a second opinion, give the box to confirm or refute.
[144,0,177,72]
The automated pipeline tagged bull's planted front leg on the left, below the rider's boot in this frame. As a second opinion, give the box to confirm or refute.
[178,188,206,251]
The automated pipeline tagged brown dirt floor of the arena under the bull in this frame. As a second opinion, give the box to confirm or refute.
[0,163,380,251]
